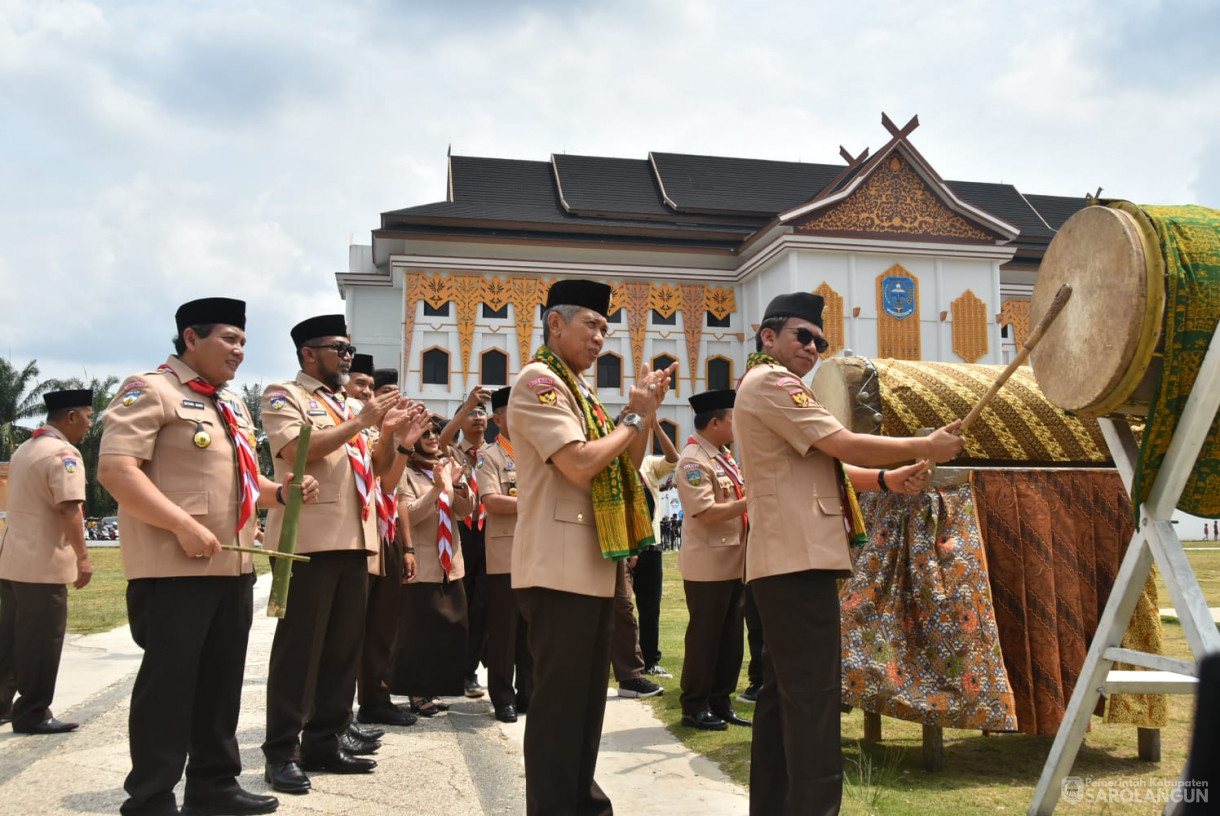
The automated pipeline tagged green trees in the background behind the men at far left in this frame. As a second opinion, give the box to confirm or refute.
[0,357,275,516]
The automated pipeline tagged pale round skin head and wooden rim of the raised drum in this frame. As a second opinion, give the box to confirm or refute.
[1030,205,1165,416]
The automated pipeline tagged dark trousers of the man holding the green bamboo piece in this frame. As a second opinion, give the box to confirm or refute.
[121,573,254,816]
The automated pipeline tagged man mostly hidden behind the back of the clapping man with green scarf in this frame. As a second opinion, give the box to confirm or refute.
[478,388,533,722]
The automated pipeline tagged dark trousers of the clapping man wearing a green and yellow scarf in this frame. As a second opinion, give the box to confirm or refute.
[516,587,615,816]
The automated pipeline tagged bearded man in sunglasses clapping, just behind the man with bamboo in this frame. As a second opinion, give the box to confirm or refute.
[262,309,407,793]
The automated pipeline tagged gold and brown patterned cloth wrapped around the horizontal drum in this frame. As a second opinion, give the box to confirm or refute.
[872,360,1111,466]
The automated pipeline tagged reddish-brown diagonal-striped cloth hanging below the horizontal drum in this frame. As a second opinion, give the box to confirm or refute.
[974,470,1168,734]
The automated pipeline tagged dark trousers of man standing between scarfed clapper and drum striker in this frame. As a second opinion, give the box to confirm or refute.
[682,579,745,715]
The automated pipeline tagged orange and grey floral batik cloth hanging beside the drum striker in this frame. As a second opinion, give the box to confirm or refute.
[839,484,1016,731]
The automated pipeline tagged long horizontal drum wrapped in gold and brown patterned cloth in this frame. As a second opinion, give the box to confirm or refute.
[813,356,1110,467]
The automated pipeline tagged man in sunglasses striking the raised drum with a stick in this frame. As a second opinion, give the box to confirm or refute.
[732,292,963,816]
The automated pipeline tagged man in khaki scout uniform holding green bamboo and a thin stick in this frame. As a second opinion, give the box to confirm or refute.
[98,298,318,816]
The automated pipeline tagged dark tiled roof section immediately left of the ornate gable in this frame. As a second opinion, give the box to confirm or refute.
[649,152,843,216]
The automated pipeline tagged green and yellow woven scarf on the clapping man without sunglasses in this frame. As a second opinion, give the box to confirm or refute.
[533,345,656,561]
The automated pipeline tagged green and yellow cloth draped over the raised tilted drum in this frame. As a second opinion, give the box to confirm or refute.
[1132,206,1220,518]
